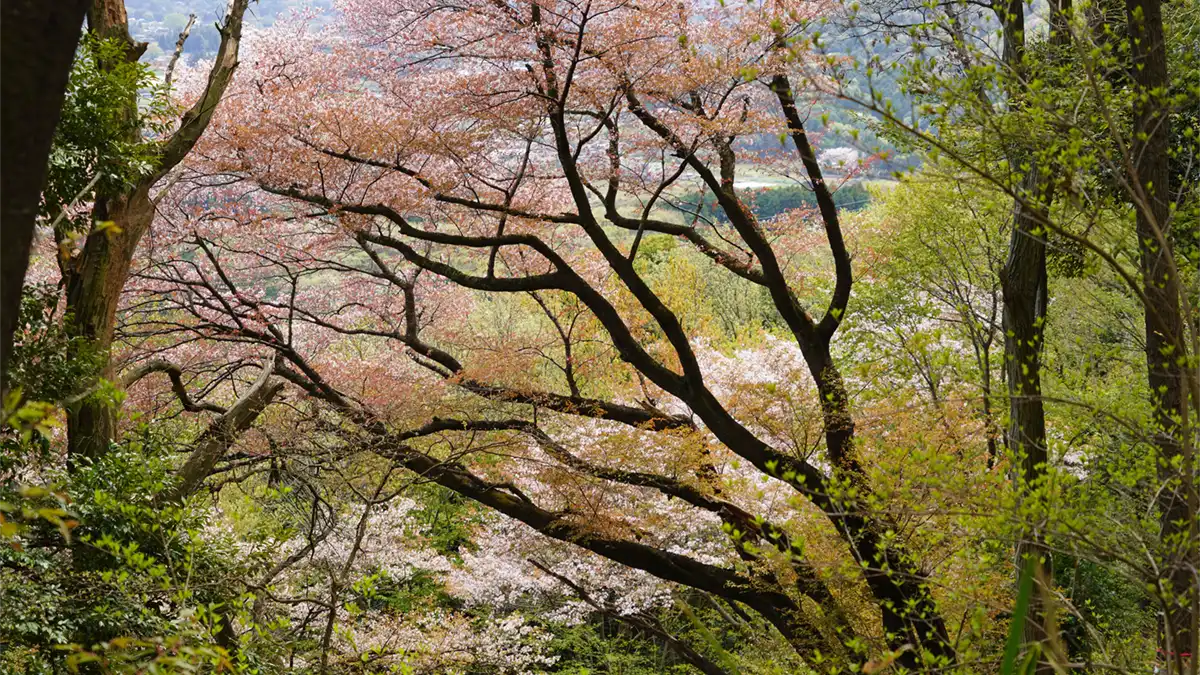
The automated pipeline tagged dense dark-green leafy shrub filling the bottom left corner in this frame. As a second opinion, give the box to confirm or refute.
[0,434,258,673]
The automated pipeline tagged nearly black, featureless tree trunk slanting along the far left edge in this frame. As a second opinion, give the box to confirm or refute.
[0,0,88,393]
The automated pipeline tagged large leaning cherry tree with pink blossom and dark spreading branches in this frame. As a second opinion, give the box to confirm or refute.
[112,0,1022,669]
